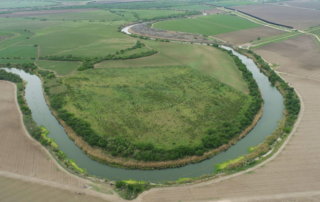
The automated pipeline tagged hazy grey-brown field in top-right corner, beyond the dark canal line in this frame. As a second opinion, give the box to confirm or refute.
[235,4,320,29]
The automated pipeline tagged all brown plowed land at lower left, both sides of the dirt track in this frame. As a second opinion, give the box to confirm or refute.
[0,81,118,202]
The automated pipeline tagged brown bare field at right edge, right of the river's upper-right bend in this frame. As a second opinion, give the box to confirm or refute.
[255,35,320,79]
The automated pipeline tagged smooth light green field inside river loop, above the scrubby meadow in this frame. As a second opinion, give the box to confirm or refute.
[97,41,248,93]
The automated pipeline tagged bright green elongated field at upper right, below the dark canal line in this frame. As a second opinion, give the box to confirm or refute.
[154,14,260,36]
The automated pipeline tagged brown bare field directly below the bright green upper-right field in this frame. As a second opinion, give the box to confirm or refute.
[214,26,284,45]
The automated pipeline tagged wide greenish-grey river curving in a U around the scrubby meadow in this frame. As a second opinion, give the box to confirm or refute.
[4,47,284,182]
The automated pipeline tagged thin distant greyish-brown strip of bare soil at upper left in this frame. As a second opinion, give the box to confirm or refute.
[0,9,98,18]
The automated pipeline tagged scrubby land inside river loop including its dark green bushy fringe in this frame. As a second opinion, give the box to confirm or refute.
[41,46,262,166]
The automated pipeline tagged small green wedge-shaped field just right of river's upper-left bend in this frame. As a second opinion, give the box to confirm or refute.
[36,60,81,76]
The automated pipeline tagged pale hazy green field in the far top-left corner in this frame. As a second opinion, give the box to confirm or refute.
[0,1,57,8]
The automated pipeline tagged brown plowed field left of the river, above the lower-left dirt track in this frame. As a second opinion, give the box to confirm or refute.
[0,81,87,187]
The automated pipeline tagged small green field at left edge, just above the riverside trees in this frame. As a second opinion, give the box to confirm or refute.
[0,45,38,58]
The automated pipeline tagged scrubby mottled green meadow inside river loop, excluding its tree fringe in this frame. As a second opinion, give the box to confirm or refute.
[62,66,250,149]
